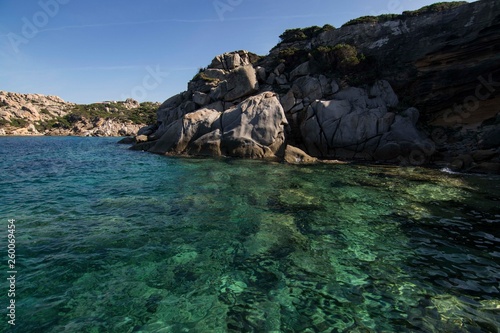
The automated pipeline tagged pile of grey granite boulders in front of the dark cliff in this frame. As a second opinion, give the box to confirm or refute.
[134,51,430,163]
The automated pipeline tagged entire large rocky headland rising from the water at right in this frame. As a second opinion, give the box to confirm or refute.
[132,0,500,172]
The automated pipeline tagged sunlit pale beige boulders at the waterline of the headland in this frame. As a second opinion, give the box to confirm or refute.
[149,92,287,158]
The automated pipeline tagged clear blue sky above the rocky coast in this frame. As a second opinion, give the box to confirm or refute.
[0,0,474,104]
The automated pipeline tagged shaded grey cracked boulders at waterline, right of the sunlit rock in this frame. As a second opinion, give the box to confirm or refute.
[301,81,434,164]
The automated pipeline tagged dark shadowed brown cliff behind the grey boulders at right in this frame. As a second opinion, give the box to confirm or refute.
[271,0,500,171]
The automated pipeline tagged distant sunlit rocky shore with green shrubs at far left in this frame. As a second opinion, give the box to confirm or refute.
[0,91,155,136]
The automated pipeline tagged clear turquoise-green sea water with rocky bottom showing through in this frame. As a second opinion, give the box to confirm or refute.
[0,137,500,333]
